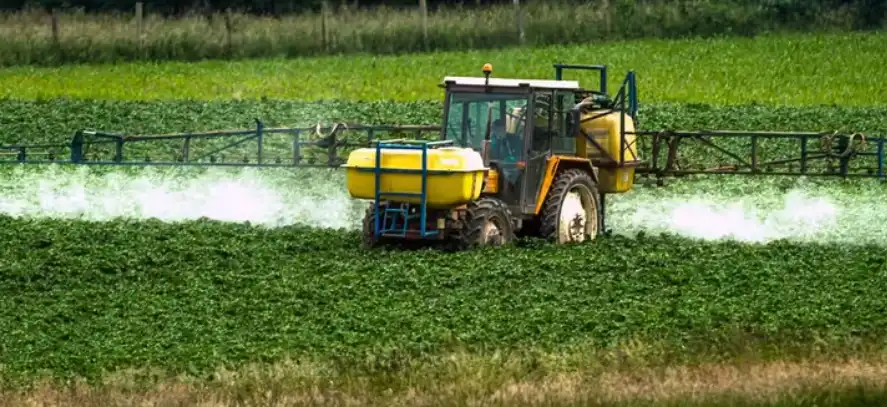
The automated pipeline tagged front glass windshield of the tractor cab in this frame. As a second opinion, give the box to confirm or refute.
[444,92,528,162]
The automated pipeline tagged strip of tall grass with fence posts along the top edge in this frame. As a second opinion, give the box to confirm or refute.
[0,1,881,66]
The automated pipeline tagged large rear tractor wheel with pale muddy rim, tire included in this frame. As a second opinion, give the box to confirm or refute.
[539,168,600,244]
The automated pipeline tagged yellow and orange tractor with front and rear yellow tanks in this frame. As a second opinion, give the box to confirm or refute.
[343,64,642,250]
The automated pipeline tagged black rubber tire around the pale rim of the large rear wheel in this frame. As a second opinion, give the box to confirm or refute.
[539,168,601,244]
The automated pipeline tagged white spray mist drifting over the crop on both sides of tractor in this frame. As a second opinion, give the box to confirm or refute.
[0,166,887,244]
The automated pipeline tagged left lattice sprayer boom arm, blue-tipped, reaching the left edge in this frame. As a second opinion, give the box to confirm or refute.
[0,119,440,167]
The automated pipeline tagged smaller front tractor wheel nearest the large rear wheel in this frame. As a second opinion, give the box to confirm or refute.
[453,197,515,250]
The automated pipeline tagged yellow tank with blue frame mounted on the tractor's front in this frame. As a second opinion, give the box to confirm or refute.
[343,147,487,208]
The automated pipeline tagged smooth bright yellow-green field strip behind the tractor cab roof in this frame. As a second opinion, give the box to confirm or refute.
[0,31,887,106]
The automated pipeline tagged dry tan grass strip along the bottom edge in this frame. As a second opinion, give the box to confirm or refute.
[0,359,887,407]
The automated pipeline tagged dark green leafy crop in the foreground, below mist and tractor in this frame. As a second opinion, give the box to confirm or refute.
[0,216,887,380]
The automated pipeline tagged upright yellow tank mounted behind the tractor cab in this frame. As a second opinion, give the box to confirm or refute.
[576,110,639,193]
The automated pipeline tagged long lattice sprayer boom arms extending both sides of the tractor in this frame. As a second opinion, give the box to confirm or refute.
[0,122,887,180]
